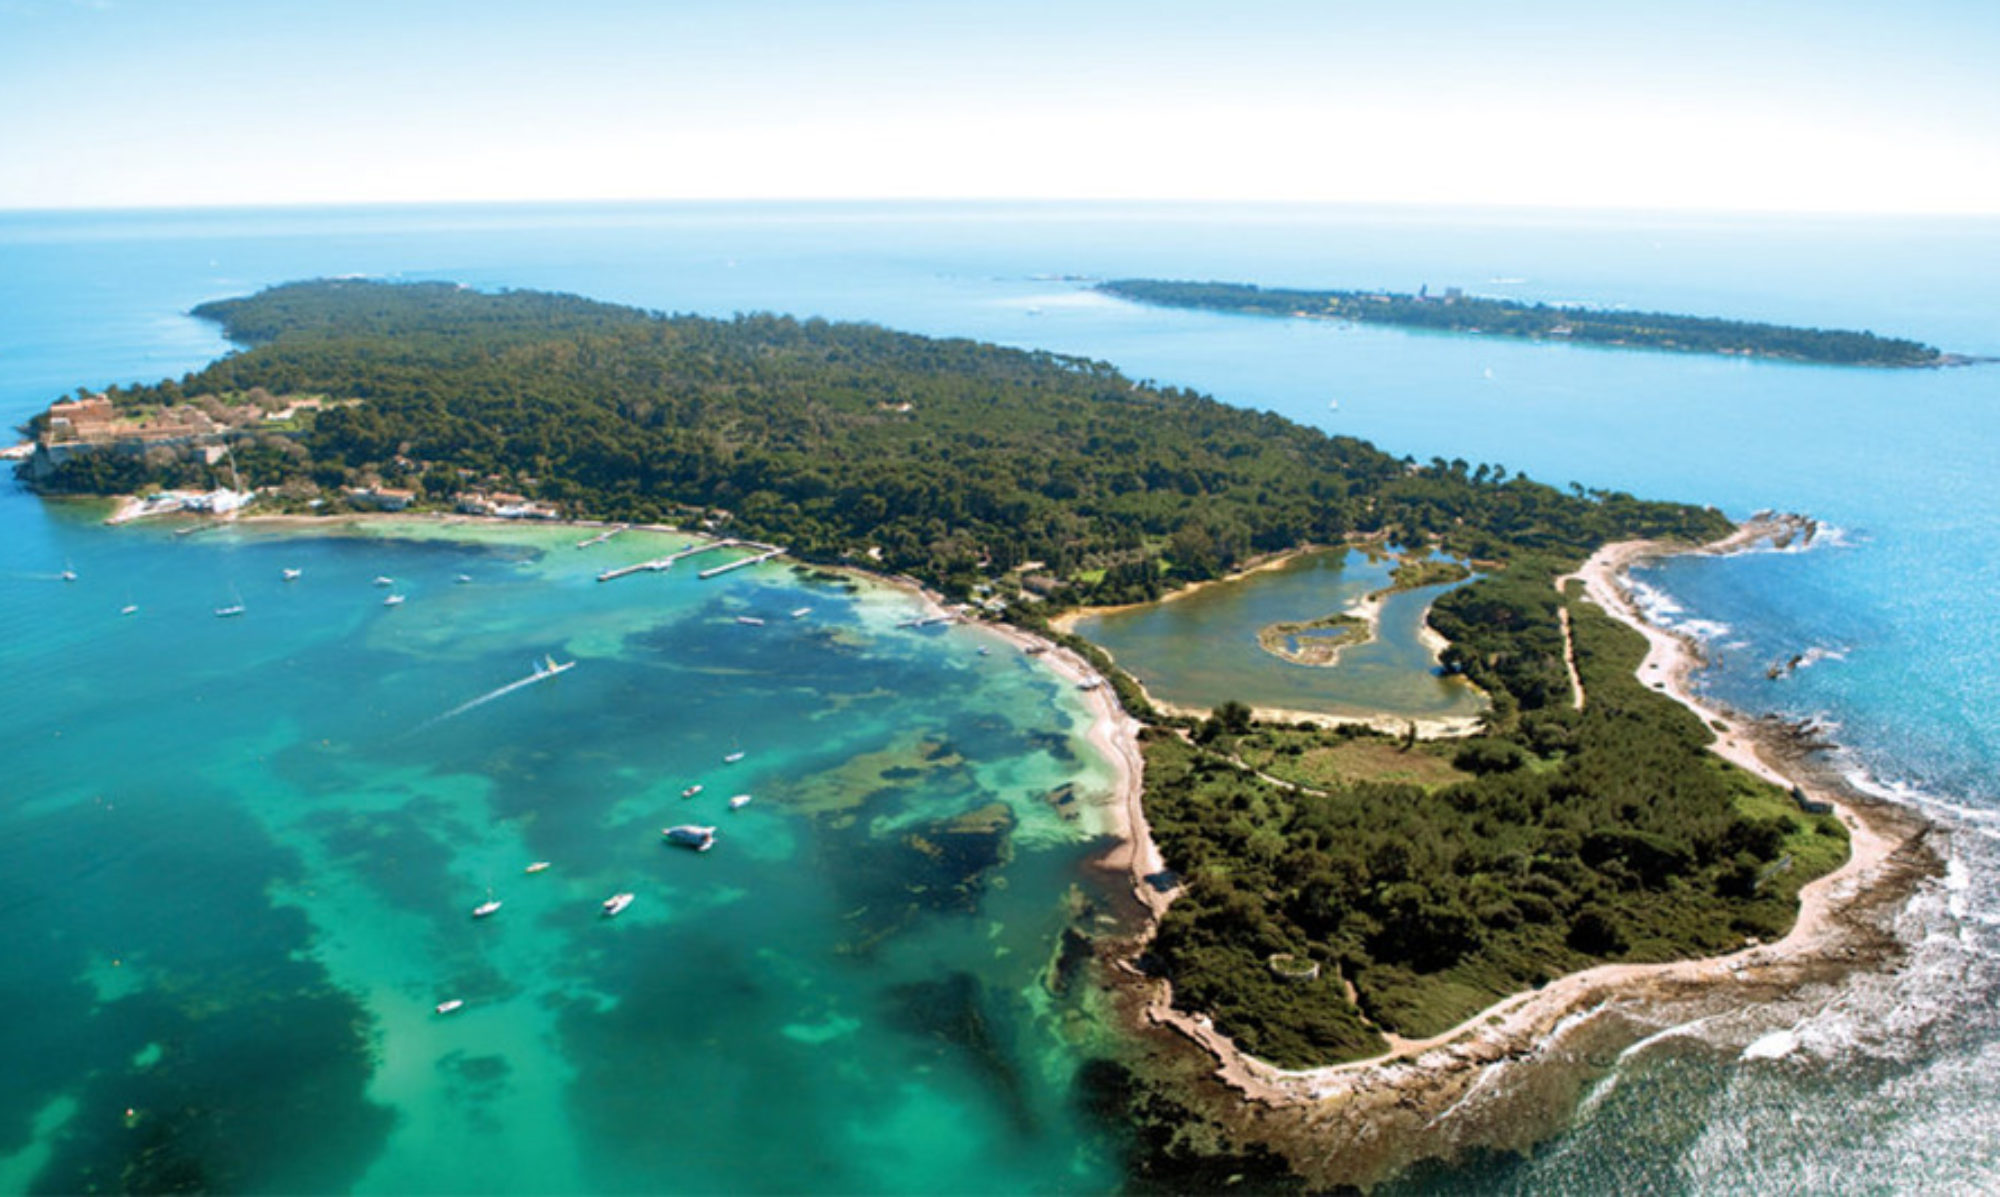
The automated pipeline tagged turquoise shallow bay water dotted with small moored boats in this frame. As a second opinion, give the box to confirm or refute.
[0,512,1112,1193]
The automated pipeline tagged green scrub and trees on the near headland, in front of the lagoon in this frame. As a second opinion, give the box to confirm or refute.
[1146,562,1848,1067]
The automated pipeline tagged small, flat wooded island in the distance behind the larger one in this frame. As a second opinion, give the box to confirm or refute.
[1096,278,1972,366]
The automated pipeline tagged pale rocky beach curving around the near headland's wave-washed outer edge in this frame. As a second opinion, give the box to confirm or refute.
[1088,524,1942,1185]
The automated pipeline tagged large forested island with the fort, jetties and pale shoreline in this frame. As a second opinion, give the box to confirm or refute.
[7,280,1928,1183]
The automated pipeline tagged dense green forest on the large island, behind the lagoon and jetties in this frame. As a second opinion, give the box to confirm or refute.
[23,280,1728,605]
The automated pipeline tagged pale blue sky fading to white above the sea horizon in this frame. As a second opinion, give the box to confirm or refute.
[0,0,2000,214]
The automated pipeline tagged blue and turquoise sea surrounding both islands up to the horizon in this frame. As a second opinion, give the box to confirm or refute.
[0,202,2000,1193]
